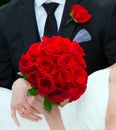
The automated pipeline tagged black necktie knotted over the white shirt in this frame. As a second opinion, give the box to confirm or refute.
[43,3,58,37]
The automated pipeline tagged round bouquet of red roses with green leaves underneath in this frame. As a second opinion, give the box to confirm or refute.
[19,36,87,111]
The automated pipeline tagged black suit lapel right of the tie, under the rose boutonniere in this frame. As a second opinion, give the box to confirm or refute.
[59,0,82,40]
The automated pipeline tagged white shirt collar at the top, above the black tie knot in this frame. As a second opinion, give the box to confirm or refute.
[35,0,66,8]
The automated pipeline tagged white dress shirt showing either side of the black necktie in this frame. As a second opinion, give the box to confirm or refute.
[34,0,66,37]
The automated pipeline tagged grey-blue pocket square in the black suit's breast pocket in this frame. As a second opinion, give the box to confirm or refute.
[73,29,91,43]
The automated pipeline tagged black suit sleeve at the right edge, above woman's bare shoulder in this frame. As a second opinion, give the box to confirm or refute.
[104,0,116,65]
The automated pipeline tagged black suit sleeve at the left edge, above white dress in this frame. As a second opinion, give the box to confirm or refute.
[0,34,15,89]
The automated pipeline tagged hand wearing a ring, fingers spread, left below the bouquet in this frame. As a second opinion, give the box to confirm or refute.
[11,78,41,126]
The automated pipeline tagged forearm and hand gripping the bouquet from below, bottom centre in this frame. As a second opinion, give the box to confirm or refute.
[28,95,65,130]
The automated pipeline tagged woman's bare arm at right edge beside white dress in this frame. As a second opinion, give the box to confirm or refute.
[106,65,116,130]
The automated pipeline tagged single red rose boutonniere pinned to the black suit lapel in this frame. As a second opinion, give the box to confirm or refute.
[66,4,92,25]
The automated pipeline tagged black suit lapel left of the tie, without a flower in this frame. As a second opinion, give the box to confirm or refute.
[19,0,40,50]
